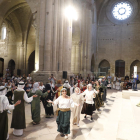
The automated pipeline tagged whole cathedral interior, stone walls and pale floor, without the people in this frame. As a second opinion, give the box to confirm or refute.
[0,0,140,140]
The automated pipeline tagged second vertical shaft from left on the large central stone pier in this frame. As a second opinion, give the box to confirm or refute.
[44,0,53,71]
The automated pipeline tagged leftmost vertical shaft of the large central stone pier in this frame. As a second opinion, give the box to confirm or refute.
[39,0,46,71]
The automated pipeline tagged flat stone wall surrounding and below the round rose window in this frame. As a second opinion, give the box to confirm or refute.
[96,1,140,76]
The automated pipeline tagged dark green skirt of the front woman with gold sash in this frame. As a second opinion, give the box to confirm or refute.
[56,111,71,134]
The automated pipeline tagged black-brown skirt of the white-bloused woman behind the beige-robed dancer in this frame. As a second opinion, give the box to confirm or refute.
[81,103,95,115]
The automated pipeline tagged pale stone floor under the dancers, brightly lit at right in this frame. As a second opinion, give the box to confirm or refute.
[8,90,140,140]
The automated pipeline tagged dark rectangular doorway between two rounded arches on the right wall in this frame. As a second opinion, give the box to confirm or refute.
[115,60,125,77]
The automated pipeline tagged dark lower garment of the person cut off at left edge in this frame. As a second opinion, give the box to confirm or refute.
[0,111,8,140]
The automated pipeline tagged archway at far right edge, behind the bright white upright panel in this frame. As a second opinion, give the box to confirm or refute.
[130,60,140,77]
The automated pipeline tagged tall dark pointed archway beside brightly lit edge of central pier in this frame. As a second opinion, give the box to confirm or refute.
[28,51,35,74]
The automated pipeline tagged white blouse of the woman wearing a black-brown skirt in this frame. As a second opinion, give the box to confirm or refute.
[82,89,98,104]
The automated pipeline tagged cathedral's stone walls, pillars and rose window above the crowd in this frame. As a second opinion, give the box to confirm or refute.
[0,0,140,80]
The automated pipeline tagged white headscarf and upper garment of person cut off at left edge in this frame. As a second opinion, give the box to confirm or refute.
[0,86,7,113]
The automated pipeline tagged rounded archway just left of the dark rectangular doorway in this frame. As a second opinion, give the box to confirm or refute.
[98,60,110,76]
